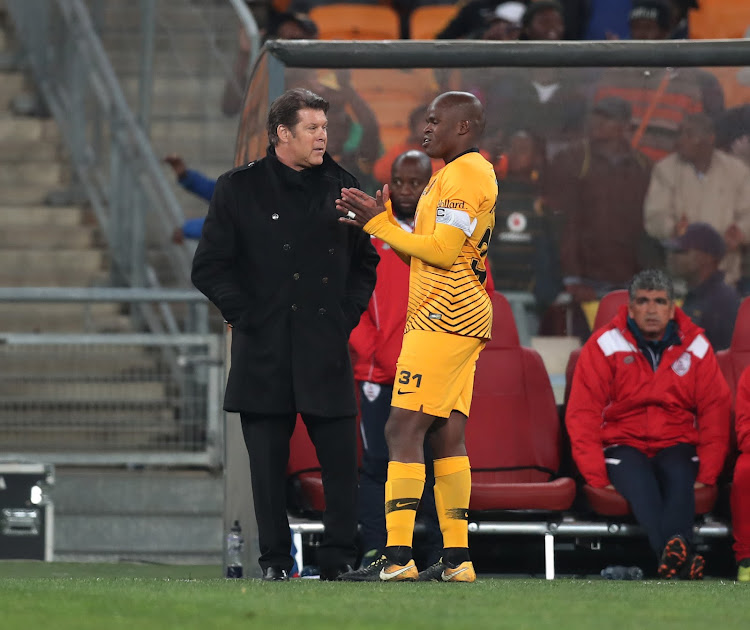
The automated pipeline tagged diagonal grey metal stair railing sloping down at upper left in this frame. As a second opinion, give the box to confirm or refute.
[6,0,190,298]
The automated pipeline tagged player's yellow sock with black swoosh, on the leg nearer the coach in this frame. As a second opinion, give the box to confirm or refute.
[385,462,425,547]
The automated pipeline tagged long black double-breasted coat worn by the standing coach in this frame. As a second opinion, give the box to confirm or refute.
[192,148,379,417]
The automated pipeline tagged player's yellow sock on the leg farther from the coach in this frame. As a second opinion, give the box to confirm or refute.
[435,457,471,548]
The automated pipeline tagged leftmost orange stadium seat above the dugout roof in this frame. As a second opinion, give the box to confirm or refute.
[310,3,400,40]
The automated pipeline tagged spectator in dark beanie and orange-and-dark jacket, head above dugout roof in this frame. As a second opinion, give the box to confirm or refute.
[594,0,724,162]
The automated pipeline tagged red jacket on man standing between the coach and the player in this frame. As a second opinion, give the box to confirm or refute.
[349,223,495,385]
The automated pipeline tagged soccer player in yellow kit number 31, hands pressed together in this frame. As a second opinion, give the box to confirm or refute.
[336,92,497,582]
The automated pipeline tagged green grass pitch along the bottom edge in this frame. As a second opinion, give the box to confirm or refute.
[0,561,750,630]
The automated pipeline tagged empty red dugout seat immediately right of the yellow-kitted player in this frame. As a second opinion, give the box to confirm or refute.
[466,293,576,511]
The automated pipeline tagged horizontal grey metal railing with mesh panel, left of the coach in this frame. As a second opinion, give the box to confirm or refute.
[0,287,224,468]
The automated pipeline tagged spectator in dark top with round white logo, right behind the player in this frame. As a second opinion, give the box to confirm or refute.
[487,131,562,310]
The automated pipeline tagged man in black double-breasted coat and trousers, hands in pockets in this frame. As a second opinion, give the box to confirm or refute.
[192,89,378,579]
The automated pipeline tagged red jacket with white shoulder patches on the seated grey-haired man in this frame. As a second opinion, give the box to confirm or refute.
[565,306,731,488]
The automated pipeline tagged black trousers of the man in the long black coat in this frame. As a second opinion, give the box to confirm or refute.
[240,413,357,571]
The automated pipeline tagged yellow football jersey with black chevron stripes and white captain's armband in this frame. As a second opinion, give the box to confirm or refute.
[404,151,497,339]
